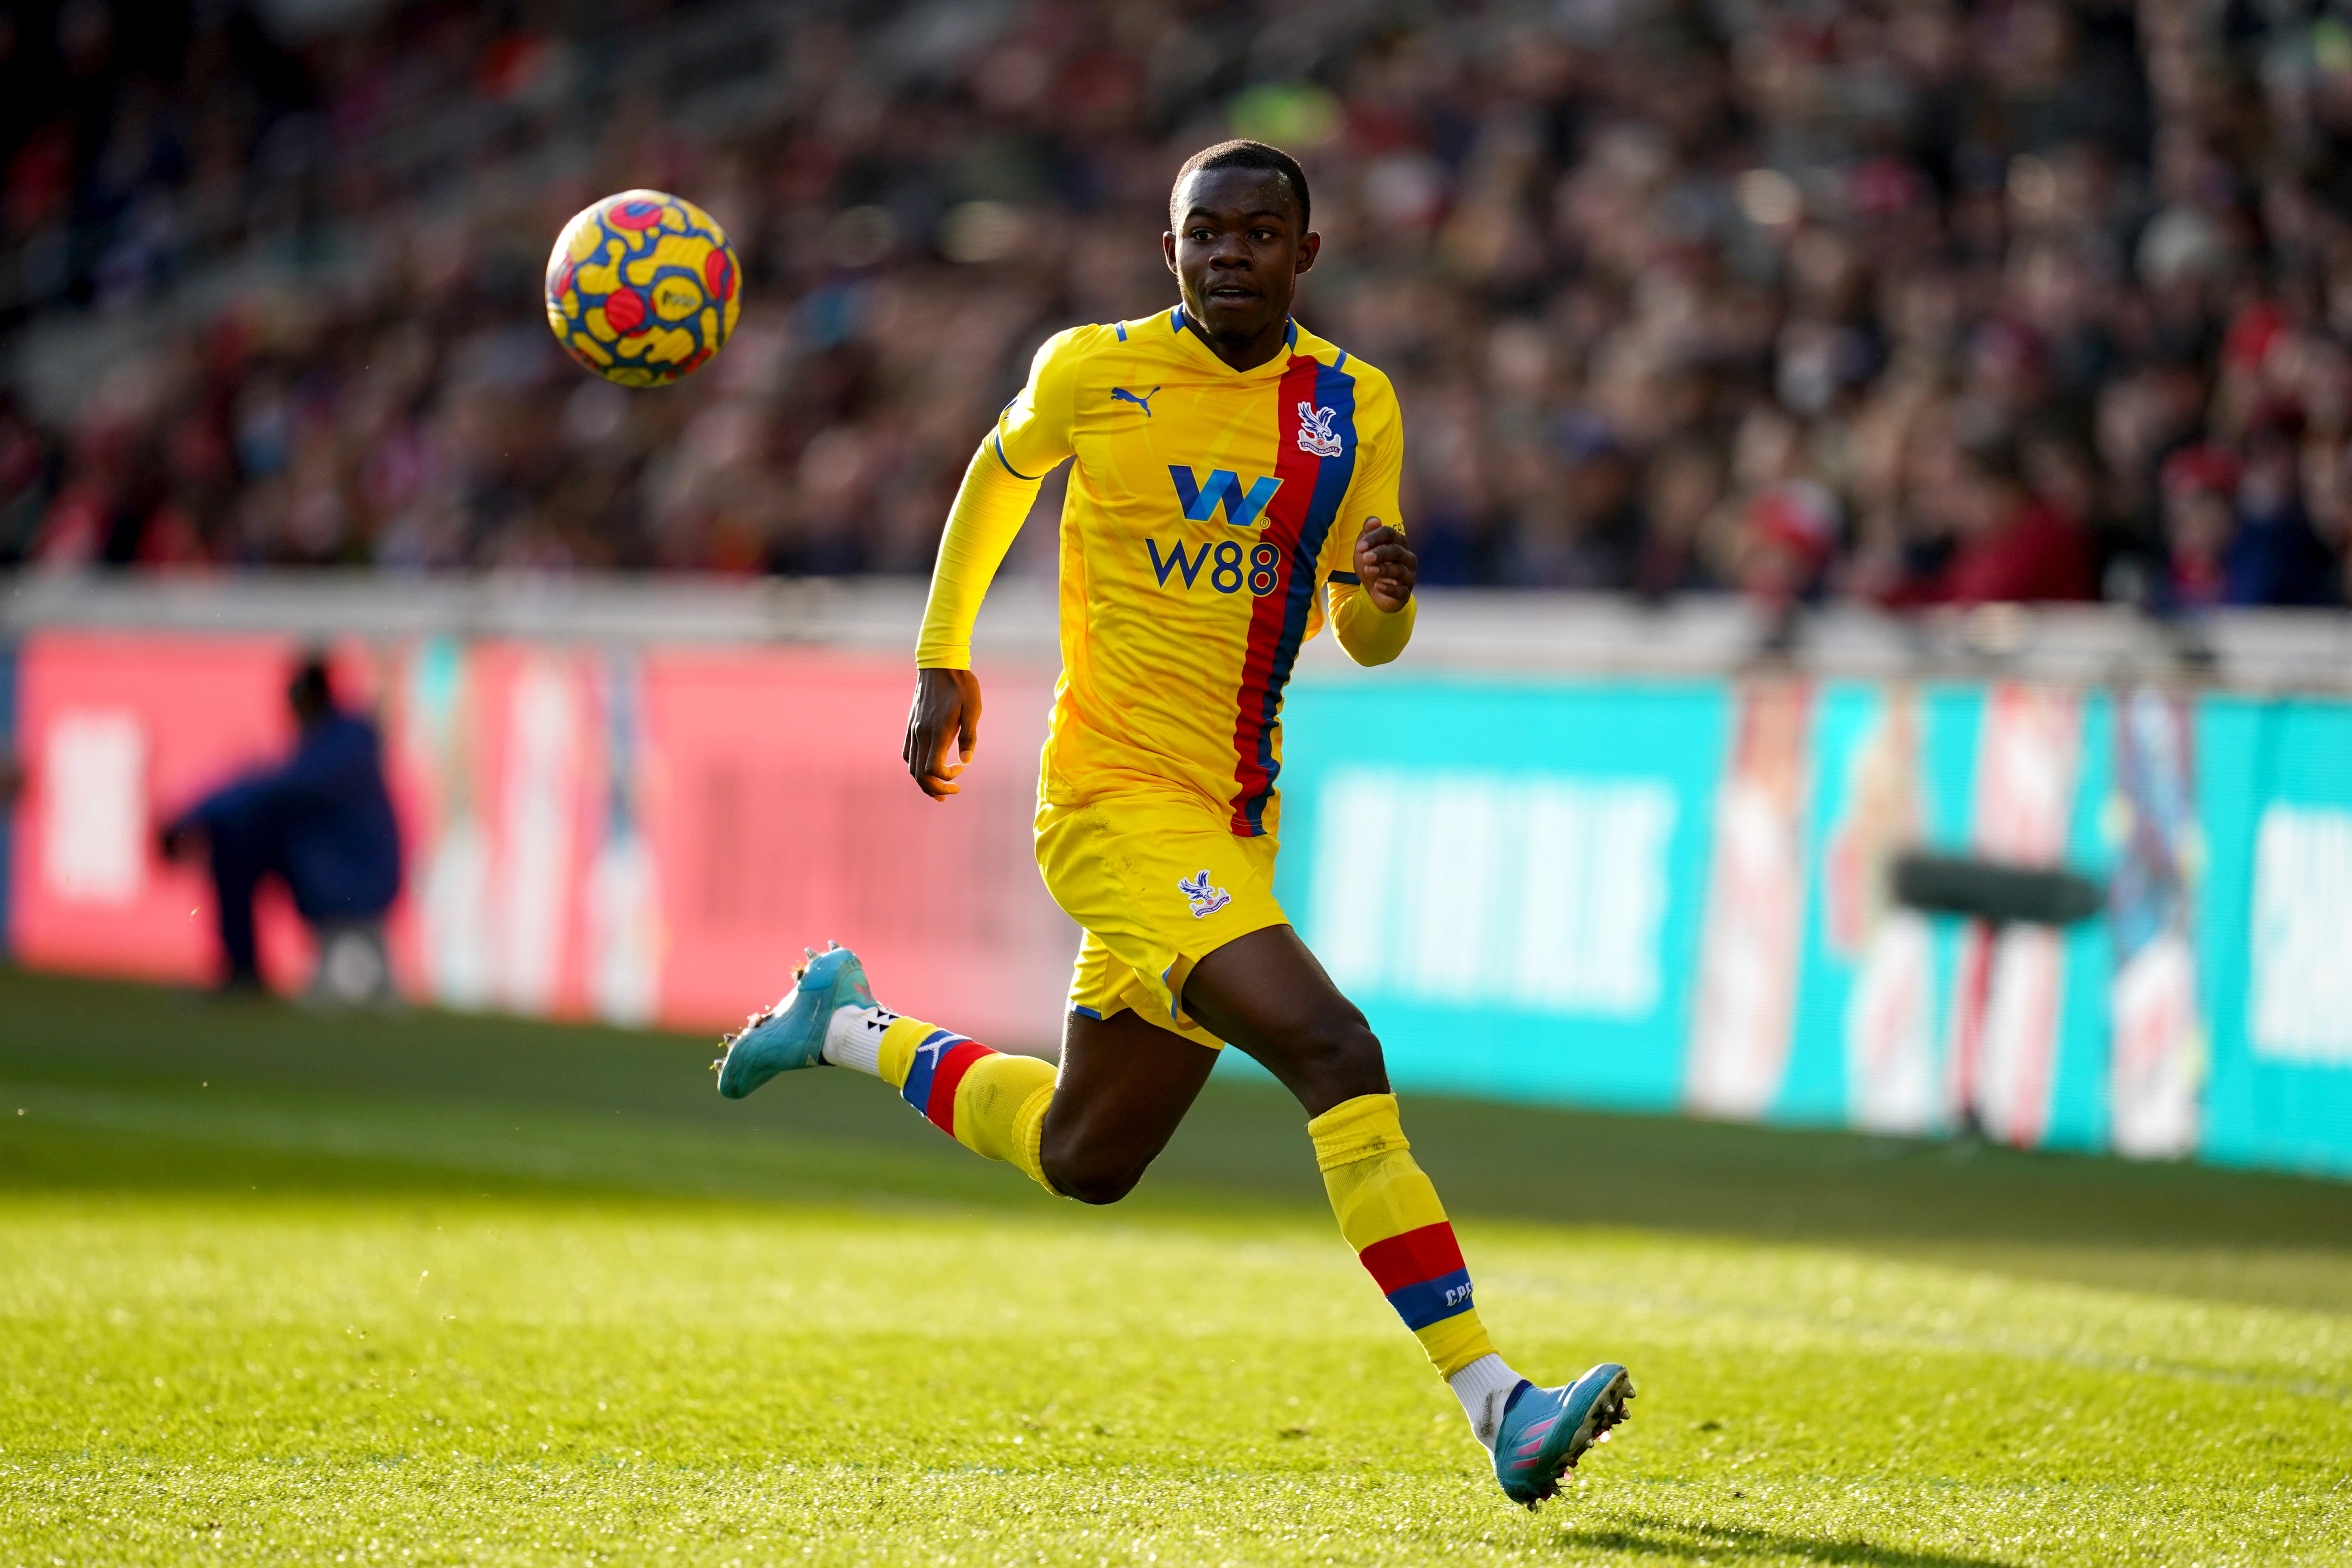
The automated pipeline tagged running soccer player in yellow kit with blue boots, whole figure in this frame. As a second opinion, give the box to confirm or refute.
[720,141,1632,1507]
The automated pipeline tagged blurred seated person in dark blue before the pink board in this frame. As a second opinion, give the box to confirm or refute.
[160,658,400,990]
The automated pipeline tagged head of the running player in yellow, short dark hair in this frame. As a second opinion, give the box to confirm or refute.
[1160,141,1322,341]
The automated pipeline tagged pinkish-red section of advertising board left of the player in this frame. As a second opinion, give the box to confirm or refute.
[9,632,1077,1046]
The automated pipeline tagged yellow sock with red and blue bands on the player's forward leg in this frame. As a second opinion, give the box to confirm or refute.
[1308,1096,1493,1378]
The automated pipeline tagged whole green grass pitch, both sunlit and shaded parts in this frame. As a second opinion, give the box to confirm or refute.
[0,971,2352,1568]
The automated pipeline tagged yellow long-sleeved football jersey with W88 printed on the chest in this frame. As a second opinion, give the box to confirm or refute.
[917,305,1411,837]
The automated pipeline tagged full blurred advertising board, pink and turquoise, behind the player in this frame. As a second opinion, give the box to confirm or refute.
[7,630,2352,1175]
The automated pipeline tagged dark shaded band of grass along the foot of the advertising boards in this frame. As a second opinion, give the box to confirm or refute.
[14,969,2352,1307]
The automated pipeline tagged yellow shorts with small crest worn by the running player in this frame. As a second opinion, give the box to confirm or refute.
[1037,794,1289,1051]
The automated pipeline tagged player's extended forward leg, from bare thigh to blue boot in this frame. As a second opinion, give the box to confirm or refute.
[1183,926,1632,1507]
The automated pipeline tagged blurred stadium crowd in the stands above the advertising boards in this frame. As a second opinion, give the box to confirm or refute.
[0,0,2352,611]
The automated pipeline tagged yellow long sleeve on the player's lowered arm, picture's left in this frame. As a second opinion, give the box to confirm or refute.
[915,327,1096,670]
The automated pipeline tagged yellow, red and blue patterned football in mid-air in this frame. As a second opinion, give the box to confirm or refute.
[548,190,743,385]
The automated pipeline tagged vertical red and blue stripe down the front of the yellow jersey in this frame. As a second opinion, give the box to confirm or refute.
[1232,355,1355,839]
